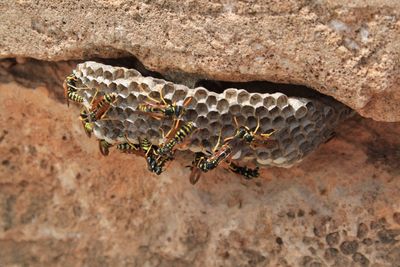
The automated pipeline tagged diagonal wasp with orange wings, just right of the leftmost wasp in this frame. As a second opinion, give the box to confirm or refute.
[80,93,118,137]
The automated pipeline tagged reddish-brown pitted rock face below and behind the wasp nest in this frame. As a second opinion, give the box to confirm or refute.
[0,83,400,266]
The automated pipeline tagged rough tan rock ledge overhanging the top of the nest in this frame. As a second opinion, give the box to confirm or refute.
[0,0,400,121]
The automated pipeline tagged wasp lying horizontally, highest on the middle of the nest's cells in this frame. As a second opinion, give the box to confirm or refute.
[137,88,193,120]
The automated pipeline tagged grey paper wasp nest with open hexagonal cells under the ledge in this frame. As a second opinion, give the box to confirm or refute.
[74,61,352,167]
